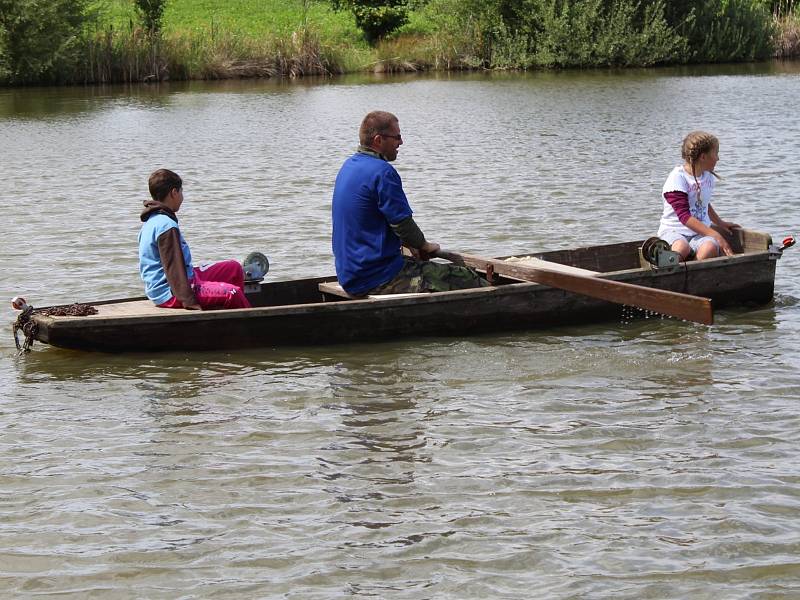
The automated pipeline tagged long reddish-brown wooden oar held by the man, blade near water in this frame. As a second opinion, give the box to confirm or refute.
[435,250,714,325]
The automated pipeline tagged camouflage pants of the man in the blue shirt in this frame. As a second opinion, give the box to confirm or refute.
[368,257,490,295]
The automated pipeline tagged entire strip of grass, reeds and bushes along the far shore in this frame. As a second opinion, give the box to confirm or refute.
[0,0,800,85]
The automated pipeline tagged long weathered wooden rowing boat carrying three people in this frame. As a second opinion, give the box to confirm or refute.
[12,230,783,352]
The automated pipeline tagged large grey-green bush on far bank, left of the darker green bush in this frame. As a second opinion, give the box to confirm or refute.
[412,0,685,69]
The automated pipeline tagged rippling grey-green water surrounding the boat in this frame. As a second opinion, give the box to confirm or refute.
[0,63,800,598]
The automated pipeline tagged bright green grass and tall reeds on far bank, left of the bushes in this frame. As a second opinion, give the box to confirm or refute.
[80,0,373,82]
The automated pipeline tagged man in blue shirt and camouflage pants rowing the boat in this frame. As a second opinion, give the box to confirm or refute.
[333,111,489,296]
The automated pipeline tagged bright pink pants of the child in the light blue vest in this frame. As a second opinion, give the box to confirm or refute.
[159,260,250,310]
